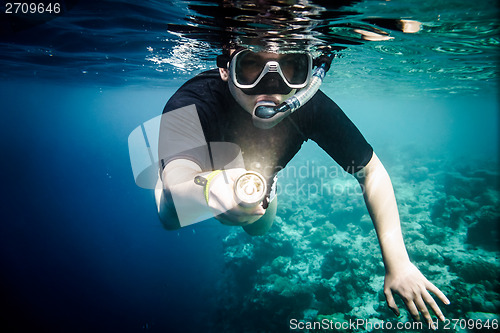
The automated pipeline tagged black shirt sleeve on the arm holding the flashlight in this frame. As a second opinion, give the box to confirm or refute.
[158,71,243,171]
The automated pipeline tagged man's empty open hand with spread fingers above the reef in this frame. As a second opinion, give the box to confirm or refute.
[384,262,450,327]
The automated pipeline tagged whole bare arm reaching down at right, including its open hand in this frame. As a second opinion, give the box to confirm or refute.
[355,153,450,323]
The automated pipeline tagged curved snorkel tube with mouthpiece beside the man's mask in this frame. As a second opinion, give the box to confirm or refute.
[252,55,333,129]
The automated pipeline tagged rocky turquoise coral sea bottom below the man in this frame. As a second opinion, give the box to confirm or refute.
[209,150,500,332]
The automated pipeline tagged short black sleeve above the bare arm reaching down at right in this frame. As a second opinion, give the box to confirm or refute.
[304,91,373,173]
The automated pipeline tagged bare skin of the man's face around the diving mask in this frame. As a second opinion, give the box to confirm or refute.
[219,52,297,114]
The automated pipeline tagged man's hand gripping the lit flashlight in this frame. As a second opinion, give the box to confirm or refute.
[208,168,266,226]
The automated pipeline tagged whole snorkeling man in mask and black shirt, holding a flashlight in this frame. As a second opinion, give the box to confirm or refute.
[155,0,449,323]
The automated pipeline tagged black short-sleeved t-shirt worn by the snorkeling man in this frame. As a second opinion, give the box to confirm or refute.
[159,70,373,187]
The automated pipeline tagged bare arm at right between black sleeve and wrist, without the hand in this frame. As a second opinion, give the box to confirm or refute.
[356,153,409,271]
